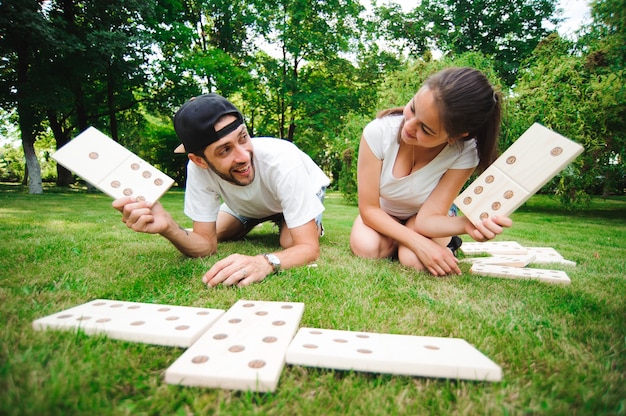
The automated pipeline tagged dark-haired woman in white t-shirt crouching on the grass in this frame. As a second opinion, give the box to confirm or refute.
[350,68,512,276]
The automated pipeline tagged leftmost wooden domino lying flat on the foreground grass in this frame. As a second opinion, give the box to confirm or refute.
[33,299,224,347]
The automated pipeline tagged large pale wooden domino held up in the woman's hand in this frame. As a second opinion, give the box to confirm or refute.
[454,123,584,224]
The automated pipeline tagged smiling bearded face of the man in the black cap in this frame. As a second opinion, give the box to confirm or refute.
[190,115,255,186]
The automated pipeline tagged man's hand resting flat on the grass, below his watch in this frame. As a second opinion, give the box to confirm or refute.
[202,254,273,287]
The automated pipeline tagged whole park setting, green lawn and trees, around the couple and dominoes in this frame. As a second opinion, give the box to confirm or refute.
[0,0,626,415]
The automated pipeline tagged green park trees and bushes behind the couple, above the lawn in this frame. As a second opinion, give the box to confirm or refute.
[0,0,626,203]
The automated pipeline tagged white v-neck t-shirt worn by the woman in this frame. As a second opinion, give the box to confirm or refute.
[363,115,478,220]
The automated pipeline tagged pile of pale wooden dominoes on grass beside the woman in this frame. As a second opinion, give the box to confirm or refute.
[460,241,576,284]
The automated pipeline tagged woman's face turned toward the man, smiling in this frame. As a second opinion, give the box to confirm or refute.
[400,88,448,148]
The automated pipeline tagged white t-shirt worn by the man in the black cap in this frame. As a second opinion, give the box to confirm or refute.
[184,137,330,228]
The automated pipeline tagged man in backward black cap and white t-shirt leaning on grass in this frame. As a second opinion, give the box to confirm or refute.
[113,94,330,287]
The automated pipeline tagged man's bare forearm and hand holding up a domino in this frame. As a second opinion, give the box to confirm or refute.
[113,198,217,257]
